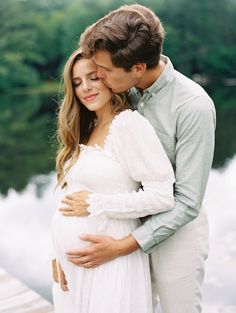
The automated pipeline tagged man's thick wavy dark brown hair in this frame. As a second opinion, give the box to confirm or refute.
[80,4,165,71]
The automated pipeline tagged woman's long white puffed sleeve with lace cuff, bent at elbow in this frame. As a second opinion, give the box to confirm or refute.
[87,110,175,218]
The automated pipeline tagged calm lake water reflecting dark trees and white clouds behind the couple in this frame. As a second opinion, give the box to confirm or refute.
[0,86,236,313]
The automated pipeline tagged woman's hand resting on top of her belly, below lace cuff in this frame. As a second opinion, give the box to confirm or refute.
[59,190,90,216]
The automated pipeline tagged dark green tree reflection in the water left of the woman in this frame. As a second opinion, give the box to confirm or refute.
[0,95,56,195]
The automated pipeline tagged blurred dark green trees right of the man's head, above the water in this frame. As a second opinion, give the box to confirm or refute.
[157,0,236,77]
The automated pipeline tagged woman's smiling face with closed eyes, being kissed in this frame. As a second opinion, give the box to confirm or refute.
[72,59,111,111]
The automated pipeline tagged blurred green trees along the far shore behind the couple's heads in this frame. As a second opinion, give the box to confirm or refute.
[0,0,236,92]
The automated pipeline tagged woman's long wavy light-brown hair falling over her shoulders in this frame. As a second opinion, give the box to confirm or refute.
[56,49,128,188]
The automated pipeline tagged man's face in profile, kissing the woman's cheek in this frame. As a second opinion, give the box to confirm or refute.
[93,50,140,93]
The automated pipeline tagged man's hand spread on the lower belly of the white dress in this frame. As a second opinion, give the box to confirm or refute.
[66,235,139,268]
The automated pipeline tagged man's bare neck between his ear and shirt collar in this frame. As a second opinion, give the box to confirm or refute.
[135,60,166,91]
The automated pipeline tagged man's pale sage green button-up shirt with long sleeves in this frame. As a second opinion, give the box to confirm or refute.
[129,56,216,252]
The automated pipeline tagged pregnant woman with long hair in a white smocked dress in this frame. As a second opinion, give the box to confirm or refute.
[52,50,174,313]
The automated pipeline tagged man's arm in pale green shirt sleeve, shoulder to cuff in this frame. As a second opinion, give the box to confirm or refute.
[132,96,215,252]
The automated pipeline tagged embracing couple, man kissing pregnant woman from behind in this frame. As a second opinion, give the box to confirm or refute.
[52,4,215,313]
